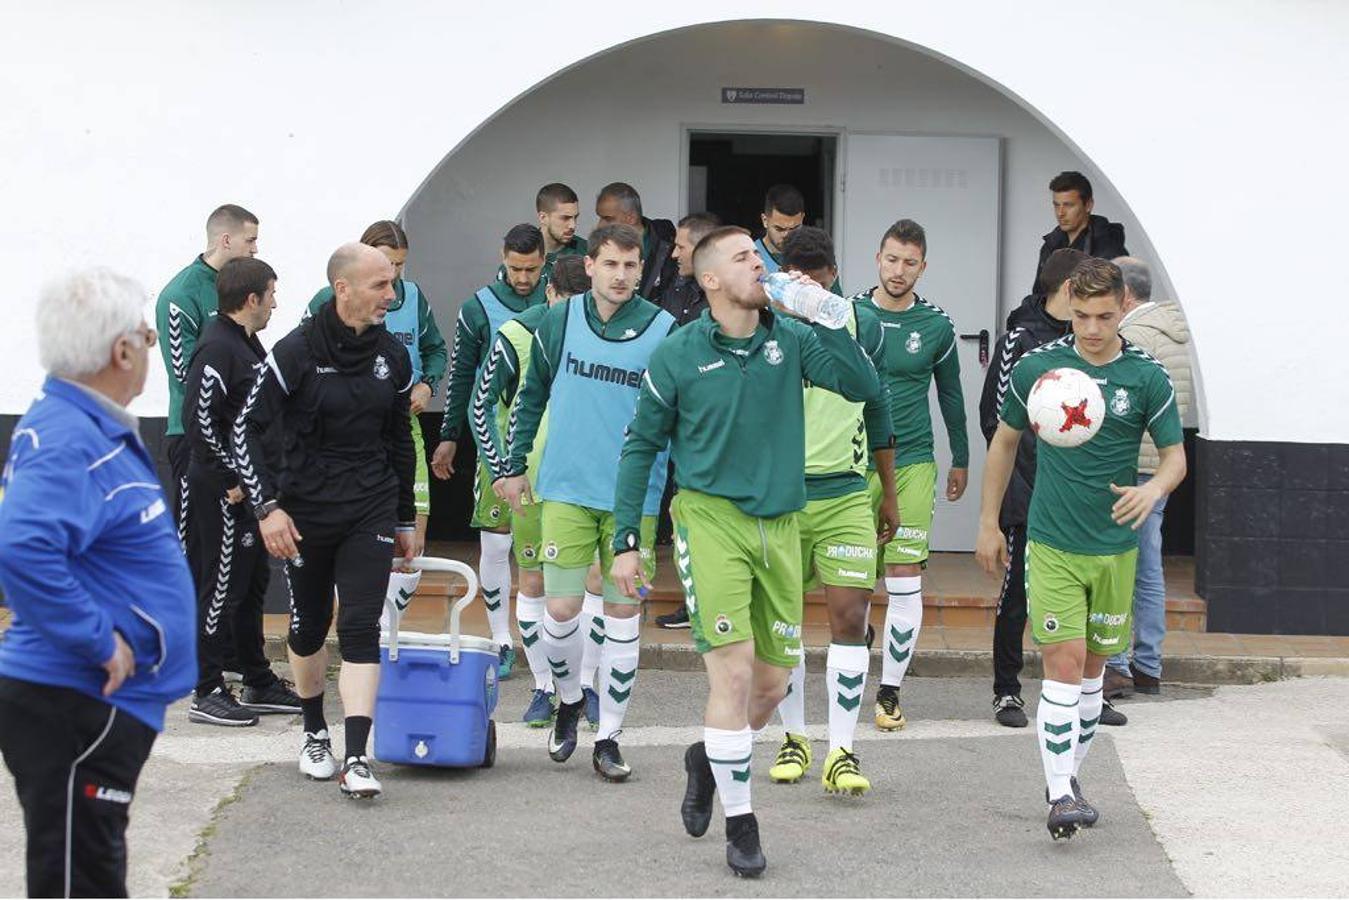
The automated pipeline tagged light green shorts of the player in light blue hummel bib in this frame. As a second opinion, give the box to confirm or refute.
[542,501,656,604]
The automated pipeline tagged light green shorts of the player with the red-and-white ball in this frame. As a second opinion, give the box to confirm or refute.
[1025,541,1139,656]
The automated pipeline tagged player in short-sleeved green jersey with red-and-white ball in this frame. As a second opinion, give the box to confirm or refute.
[975,259,1186,839]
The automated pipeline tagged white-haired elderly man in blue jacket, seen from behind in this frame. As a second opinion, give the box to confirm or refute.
[0,270,197,897]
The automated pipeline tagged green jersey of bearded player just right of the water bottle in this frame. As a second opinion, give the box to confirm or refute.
[853,287,970,468]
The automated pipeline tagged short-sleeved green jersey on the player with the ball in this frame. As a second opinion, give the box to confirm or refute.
[1001,335,1183,556]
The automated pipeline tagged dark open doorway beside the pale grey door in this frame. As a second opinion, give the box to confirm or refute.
[688,131,838,237]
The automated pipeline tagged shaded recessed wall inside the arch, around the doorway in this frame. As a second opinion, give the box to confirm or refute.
[406,23,1167,356]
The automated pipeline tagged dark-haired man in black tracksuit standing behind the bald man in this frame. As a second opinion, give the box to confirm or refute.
[182,256,299,726]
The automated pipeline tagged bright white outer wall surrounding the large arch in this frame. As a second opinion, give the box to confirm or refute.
[0,0,1349,441]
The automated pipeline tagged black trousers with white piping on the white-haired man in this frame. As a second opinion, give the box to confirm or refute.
[0,677,156,897]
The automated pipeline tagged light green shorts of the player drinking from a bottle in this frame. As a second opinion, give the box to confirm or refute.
[670,490,801,668]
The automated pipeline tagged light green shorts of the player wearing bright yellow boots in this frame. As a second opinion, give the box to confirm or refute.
[796,490,876,591]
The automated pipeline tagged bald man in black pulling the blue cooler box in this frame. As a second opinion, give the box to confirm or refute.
[232,244,417,797]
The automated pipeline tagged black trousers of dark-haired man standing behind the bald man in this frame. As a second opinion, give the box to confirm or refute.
[186,478,277,696]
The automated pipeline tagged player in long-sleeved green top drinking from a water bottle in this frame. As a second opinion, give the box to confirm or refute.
[612,227,881,877]
